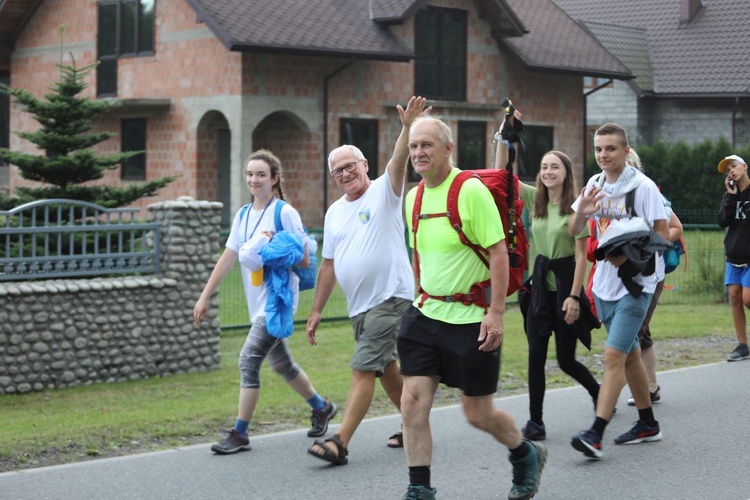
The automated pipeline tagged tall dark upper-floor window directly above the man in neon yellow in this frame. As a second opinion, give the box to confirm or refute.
[414,7,467,101]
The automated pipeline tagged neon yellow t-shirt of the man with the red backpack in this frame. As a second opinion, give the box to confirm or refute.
[404,168,505,324]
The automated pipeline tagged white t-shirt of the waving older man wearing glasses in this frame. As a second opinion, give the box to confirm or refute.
[322,171,414,317]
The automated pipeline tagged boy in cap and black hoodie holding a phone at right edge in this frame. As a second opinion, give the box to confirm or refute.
[718,155,750,361]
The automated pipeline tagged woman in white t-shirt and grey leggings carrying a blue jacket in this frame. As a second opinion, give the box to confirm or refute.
[193,149,338,455]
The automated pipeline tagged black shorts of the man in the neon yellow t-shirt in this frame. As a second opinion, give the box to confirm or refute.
[398,306,501,396]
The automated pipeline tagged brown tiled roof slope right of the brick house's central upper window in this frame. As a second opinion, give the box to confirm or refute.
[503,0,632,79]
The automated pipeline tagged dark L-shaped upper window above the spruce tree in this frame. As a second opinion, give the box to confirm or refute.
[96,0,155,97]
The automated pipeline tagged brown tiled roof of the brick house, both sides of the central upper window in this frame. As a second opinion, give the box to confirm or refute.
[187,0,632,78]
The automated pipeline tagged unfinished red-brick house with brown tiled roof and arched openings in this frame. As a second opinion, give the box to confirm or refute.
[0,0,631,227]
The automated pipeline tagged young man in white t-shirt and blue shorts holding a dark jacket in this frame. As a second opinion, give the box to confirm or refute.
[568,123,669,458]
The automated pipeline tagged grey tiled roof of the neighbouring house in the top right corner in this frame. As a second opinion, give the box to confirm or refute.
[555,0,750,96]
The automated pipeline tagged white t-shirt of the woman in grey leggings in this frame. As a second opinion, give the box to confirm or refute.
[226,197,308,323]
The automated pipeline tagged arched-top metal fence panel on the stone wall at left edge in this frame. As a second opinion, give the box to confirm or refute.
[0,199,161,281]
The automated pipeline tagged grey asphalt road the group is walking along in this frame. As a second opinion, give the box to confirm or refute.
[0,361,750,500]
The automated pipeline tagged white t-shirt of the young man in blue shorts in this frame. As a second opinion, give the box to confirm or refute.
[573,172,667,301]
